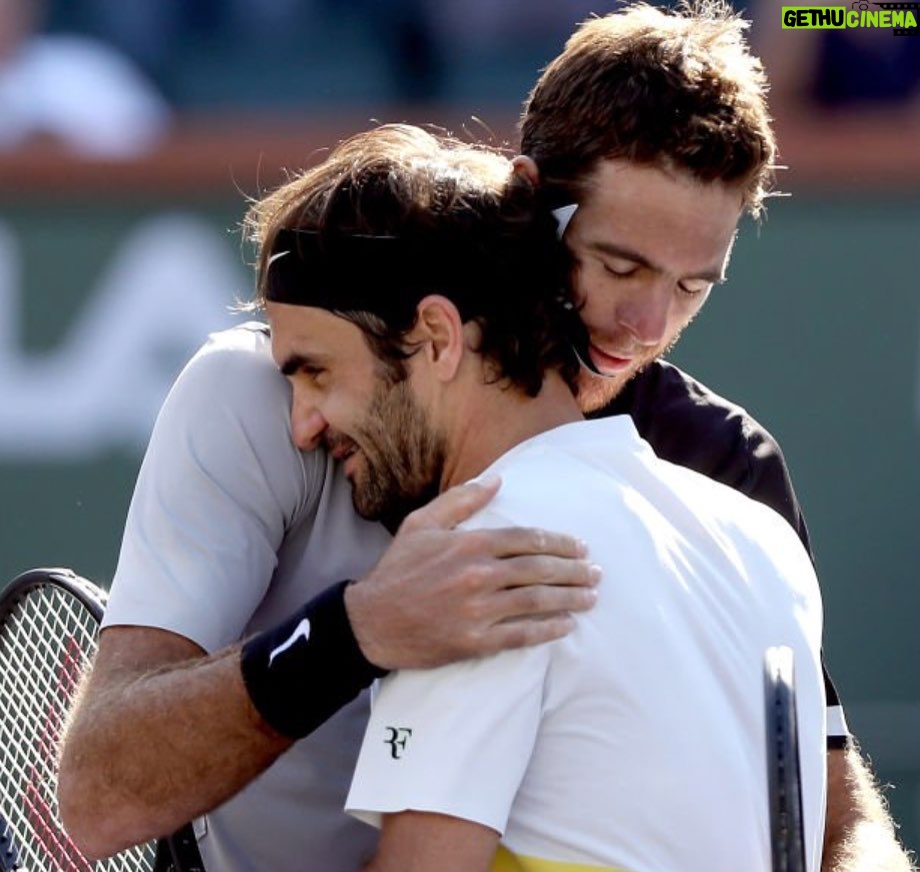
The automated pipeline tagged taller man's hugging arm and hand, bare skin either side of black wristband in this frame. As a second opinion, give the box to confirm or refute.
[59,485,597,858]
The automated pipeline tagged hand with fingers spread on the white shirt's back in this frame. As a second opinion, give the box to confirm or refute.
[345,494,601,669]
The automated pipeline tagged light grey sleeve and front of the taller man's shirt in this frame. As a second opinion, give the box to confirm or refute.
[103,323,390,872]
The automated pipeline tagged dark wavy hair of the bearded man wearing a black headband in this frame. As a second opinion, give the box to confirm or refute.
[245,124,584,396]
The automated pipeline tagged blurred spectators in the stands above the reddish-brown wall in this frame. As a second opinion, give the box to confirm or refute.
[0,0,920,157]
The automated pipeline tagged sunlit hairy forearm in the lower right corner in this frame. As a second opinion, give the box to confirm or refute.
[821,747,916,872]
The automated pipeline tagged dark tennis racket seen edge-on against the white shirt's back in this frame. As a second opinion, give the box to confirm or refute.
[764,646,806,872]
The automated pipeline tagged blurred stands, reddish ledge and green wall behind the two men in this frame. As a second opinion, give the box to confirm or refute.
[0,0,920,849]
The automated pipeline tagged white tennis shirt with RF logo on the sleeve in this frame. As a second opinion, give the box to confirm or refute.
[347,417,826,872]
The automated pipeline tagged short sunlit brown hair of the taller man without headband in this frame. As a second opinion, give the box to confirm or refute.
[520,0,776,217]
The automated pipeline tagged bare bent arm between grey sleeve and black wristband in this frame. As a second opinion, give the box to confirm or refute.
[58,627,292,859]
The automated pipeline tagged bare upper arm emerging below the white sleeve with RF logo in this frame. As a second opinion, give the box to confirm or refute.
[365,811,499,872]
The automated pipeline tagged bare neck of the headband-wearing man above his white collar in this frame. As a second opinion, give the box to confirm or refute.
[441,373,584,490]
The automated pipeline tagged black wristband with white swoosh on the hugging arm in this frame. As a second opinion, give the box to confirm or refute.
[240,581,387,739]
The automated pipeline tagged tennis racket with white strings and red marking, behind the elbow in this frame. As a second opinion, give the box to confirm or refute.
[0,569,202,872]
